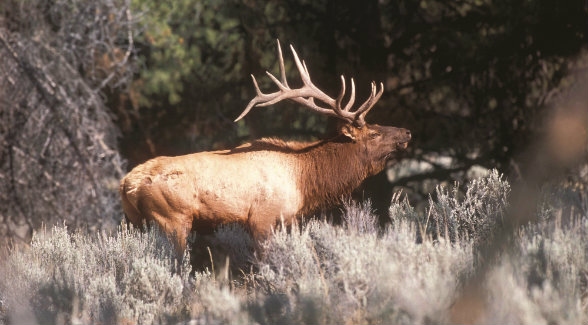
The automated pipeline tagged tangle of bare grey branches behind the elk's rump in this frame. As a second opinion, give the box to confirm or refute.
[0,0,136,245]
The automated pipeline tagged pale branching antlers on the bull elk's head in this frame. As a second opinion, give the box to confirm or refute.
[235,40,384,127]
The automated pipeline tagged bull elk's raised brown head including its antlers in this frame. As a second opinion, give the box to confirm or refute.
[235,40,411,170]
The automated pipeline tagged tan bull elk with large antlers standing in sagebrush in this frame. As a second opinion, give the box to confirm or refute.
[120,41,410,251]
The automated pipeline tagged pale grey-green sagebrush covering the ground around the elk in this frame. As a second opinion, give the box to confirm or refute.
[0,171,588,324]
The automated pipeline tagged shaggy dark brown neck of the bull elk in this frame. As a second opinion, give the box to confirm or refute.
[296,136,385,214]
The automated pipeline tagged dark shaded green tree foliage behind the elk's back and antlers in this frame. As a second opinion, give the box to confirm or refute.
[121,0,588,205]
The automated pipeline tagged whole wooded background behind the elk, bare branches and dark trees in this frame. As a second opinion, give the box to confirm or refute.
[0,0,588,244]
